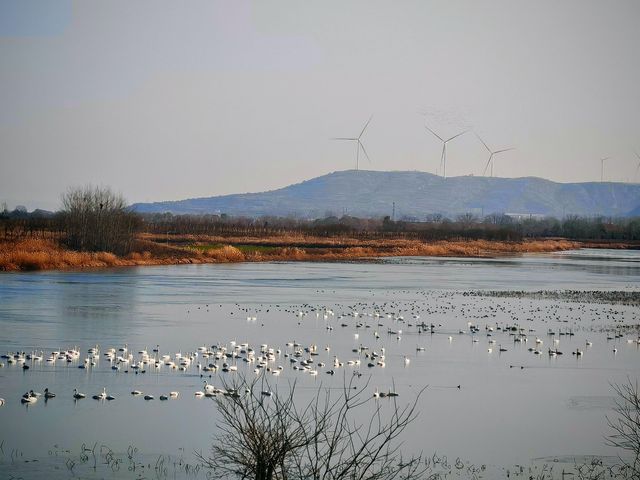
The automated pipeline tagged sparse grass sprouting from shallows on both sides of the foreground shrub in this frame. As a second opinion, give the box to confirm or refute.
[0,441,634,480]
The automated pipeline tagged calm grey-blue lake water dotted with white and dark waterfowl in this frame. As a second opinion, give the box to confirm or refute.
[0,250,640,478]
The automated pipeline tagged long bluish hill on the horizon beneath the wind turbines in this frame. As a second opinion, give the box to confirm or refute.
[133,170,640,219]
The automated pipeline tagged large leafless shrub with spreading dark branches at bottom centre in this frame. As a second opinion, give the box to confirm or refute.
[198,377,426,480]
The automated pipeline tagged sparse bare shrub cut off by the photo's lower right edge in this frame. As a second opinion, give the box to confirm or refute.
[607,378,640,478]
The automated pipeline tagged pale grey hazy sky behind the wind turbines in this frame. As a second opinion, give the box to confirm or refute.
[0,0,640,210]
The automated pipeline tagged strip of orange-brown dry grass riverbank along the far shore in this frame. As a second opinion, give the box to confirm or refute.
[0,235,629,271]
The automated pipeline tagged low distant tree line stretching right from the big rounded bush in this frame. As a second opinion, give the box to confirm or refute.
[119,213,640,241]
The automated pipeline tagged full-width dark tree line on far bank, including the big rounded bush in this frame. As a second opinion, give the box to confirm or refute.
[0,186,640,254]
